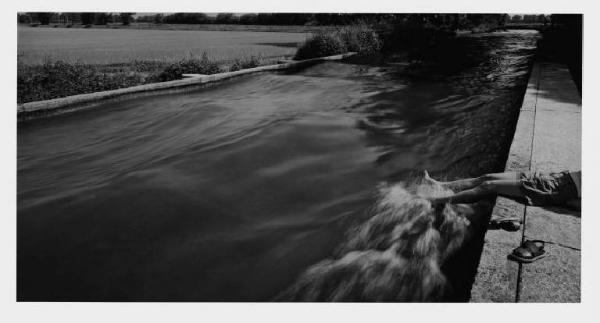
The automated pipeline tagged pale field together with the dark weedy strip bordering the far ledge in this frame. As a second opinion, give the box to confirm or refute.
[17,26,309,103]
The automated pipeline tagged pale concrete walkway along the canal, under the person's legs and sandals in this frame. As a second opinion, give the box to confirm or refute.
[471,62,582,302]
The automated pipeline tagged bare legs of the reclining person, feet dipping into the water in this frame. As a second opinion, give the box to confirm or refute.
[424,171,524,204]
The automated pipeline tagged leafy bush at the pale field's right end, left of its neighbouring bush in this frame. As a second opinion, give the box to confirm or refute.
[294,32,347,60]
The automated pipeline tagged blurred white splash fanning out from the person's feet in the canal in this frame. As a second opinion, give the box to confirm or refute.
[277,183,470,301]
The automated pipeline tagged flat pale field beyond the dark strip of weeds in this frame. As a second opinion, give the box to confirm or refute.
[17,26,308,64]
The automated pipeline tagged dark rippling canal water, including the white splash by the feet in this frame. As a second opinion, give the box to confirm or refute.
[17,31,537,301]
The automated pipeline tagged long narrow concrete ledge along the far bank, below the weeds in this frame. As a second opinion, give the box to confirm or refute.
[17,52,356,121]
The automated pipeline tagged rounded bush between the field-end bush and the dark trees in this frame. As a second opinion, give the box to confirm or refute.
[339,23,383,56]
